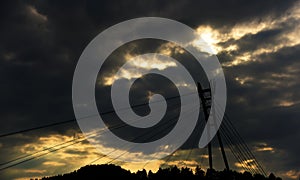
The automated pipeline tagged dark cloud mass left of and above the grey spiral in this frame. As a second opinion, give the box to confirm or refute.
[1,1,291,134]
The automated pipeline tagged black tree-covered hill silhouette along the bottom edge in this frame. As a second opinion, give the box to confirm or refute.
[38,164,281,180]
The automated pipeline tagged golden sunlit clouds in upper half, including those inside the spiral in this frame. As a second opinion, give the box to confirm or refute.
[102,3,300,86]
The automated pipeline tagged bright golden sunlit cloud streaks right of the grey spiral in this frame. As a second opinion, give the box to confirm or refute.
[194,2,300,67]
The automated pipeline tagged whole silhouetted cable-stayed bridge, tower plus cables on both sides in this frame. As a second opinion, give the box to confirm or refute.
[0,83,266,176]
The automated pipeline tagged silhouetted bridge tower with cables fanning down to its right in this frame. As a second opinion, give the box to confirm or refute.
[192,83,266,175]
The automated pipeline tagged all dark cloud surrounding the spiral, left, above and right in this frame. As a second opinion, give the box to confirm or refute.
[0,0,300,179]
